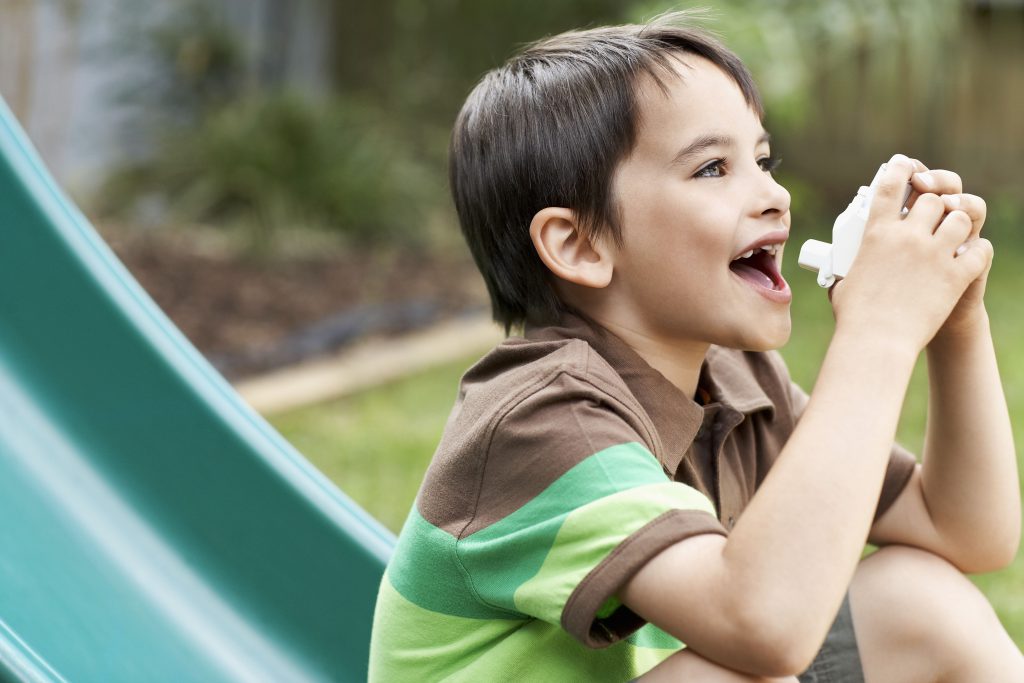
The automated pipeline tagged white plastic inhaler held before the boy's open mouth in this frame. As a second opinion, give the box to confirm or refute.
[797,164,910,289]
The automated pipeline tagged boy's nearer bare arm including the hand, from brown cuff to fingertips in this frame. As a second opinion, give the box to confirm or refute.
[620,160,991,676]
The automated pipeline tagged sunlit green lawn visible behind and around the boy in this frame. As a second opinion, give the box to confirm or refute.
[271,246,1024,645]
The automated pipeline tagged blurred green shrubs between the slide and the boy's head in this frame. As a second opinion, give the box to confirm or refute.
[94,2,437,249]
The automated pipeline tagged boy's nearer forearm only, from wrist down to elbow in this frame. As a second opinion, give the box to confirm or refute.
[725,331,915,651]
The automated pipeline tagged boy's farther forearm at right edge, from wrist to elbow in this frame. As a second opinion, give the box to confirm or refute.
[922,315,1021,570]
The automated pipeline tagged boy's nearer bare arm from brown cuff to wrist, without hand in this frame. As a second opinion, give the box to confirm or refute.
[621,331,916,676]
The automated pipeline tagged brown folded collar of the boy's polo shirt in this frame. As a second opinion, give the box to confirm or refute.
[524,313,773,473]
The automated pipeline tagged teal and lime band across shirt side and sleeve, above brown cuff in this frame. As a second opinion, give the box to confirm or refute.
[388,442,714,624]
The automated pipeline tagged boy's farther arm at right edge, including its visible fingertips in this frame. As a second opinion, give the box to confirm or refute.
[870,185,1021,571]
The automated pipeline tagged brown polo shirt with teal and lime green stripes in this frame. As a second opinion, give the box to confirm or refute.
[370,315,914,681]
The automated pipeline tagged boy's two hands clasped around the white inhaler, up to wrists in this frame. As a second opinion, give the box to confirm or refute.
[833,155,992,353]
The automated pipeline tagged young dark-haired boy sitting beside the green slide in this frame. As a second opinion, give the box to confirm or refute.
[371,14,1024,683]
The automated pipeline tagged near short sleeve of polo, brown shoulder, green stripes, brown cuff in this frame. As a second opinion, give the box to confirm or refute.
[456,374,726,647]
